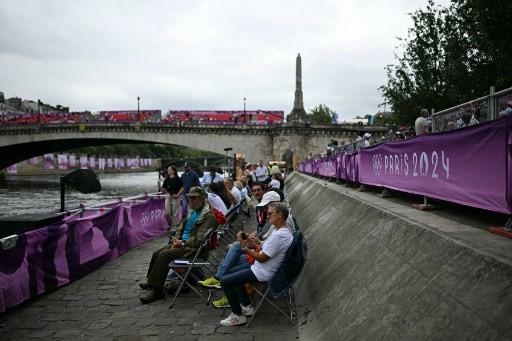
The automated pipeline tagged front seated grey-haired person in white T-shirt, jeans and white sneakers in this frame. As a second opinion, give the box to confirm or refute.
[220,202,293,327]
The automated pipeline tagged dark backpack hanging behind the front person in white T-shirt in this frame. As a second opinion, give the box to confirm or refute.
[270,231,307,297]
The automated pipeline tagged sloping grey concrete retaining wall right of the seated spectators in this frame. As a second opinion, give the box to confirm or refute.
[287,174,512,341]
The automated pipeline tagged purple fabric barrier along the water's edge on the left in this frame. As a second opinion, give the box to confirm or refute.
[0,198,167,313]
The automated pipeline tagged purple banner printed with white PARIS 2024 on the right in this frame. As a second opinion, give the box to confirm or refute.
[359,116,512,214]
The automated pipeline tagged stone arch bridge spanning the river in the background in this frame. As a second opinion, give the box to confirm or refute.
[0,123,386,169]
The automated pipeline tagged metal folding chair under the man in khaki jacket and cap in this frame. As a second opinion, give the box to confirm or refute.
[169,228,217,309]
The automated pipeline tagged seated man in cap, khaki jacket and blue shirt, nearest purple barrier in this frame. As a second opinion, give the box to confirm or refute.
[140,187,217,304]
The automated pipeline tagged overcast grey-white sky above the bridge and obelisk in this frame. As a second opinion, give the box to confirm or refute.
[0,0,448,118]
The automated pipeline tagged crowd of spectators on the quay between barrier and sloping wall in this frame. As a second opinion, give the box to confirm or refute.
[140,161,295,326]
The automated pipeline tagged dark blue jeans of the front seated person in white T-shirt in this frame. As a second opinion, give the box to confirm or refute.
[220,268,258,315]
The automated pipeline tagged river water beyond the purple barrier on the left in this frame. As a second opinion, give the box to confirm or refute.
[0,172,162,217]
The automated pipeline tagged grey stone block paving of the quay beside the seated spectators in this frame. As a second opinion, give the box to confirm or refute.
[0,237,298,341]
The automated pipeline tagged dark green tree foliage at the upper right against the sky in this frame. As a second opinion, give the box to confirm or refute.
[380,0,512,124]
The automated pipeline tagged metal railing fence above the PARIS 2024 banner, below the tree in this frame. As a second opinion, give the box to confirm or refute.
[432,86,512,133]
